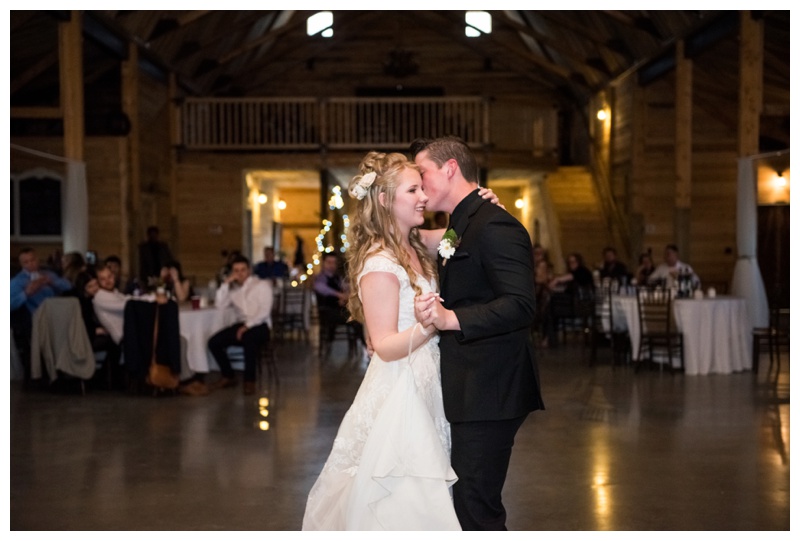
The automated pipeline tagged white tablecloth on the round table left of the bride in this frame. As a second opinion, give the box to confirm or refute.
[179,306,236,373]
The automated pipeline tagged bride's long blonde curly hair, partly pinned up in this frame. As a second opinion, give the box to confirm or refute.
[346,152,436,322]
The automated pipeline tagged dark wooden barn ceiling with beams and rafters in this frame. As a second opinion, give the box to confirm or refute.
[10,10,789,121]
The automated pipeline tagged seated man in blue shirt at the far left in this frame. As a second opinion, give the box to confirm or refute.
[11,248,72,369]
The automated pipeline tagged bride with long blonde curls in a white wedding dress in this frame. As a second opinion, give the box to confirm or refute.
[303,152,496,530]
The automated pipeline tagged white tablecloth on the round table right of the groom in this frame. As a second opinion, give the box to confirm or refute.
[612,295,752,375]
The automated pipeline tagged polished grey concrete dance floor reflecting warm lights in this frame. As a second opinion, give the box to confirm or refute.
[9,337,790,531]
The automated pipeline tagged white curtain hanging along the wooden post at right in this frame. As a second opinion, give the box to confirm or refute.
[731,157,769,327]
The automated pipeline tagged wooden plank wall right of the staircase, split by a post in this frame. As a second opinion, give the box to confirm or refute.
[611,50,737,287]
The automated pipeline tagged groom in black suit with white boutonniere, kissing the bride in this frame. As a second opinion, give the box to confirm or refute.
[411,137,544,530]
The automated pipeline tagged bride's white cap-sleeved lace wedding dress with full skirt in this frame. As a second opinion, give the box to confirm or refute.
[303,252,460,530]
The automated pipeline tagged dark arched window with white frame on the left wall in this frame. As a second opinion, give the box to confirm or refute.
[10,169,63,240]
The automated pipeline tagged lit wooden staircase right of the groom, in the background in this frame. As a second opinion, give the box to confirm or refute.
[543,166,624,272]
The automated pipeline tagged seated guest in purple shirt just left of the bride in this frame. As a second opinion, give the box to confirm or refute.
[314,252,364,342]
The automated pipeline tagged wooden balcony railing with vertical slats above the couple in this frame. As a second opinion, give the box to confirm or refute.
[181,97,555,155]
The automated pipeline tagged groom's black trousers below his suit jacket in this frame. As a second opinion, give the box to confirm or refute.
[450,414,527,530]
